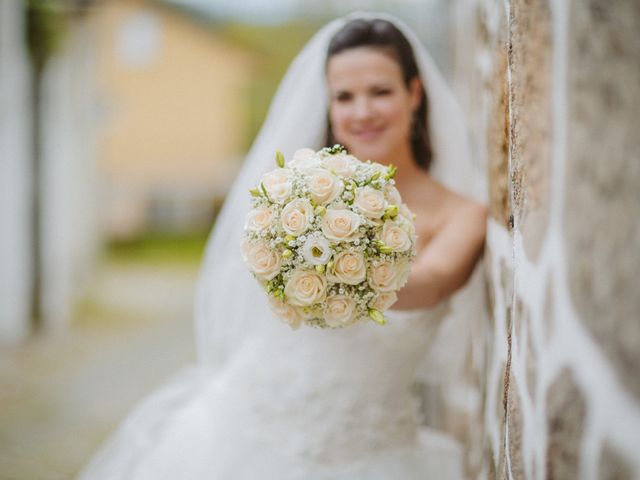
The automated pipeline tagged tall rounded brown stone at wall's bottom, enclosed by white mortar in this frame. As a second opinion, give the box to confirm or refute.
[546,370,587,480]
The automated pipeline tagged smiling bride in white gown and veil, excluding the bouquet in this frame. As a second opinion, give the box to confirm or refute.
[80,14,486,480]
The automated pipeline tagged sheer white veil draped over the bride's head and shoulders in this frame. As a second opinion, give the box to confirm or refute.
[195,13,480,374]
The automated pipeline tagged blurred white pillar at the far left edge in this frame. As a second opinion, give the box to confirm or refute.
[0,2,30,341]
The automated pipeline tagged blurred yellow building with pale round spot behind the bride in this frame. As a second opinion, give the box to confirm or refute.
[92,0,251,238]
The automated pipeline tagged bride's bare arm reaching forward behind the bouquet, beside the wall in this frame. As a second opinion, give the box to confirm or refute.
[393,202,487,310]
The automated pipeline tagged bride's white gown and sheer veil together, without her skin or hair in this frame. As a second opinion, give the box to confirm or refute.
[80,14,484,480]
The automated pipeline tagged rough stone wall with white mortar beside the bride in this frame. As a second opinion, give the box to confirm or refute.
[452,0,640,480]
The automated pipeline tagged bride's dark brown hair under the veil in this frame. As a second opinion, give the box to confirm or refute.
[325,18,432,170]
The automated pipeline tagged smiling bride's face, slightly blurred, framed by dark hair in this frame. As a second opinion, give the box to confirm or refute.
[327,47,421,163]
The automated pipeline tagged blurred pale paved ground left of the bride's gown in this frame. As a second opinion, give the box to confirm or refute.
[0,263,197,480]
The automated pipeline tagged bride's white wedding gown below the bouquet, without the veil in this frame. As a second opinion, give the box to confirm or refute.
[82,303,463,480]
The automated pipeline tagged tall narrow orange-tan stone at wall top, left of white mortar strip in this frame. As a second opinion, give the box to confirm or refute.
[509,0,552,260]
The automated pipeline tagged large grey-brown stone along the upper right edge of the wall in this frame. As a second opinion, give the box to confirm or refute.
[564,0,640,398]
